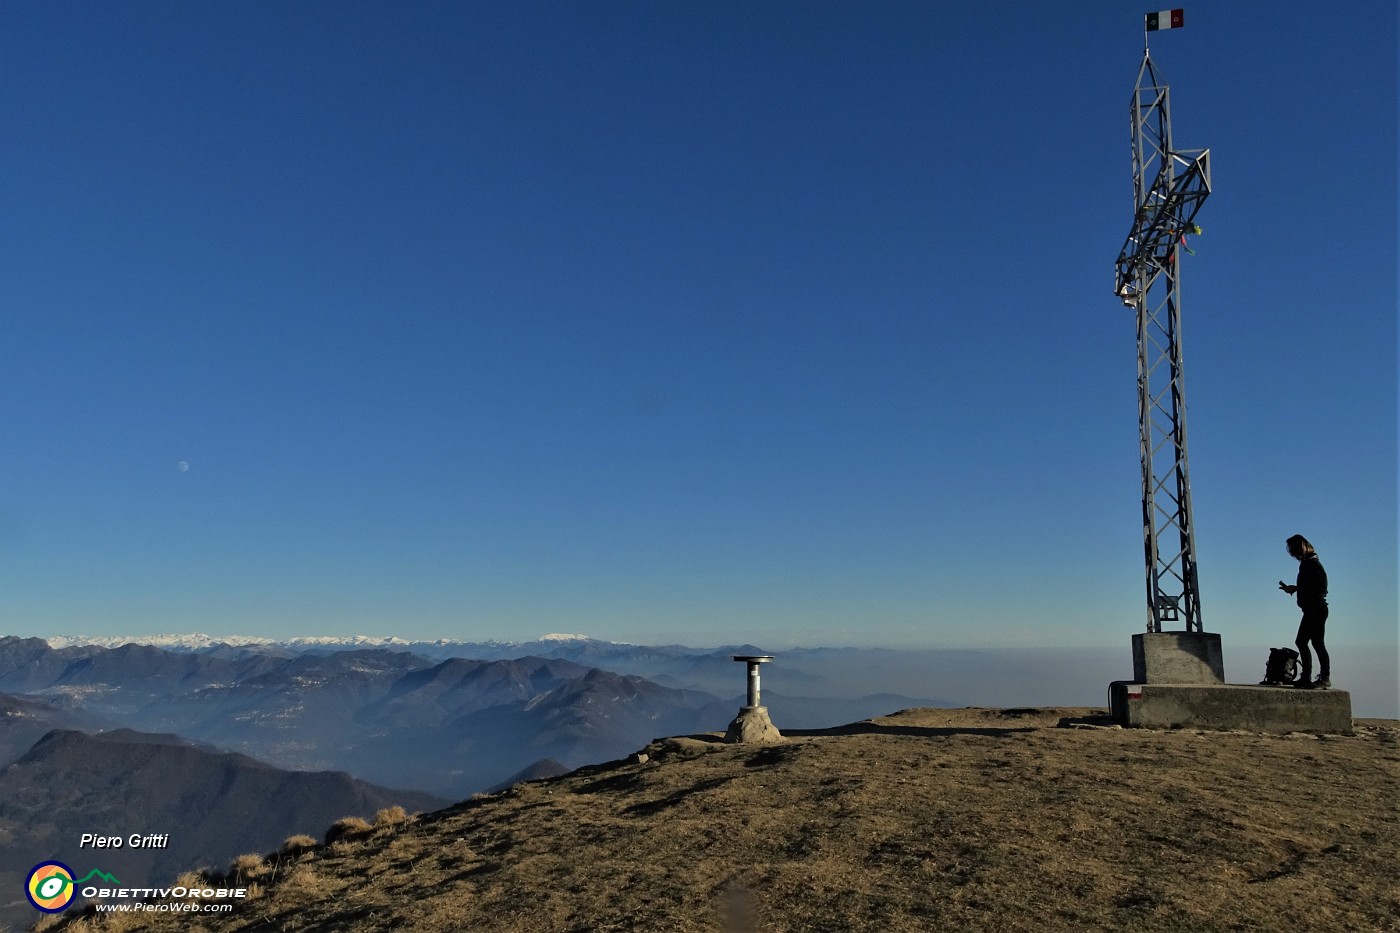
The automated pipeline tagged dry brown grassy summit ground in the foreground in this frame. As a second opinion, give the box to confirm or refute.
[40,709,1400,933]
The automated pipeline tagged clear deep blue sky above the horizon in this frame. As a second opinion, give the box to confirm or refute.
[0,0,1397,665]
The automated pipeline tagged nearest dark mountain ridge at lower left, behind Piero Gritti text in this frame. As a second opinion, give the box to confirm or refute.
[0,730,445,929]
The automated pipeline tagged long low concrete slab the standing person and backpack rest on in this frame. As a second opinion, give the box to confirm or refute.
[1109,681,1351,734]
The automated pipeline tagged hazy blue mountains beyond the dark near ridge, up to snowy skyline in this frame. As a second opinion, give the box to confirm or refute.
[0,637,734,797]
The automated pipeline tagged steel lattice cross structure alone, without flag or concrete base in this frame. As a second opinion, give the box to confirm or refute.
[1114,50,1211,632]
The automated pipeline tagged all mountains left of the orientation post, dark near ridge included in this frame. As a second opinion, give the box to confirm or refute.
[0,627,756,922]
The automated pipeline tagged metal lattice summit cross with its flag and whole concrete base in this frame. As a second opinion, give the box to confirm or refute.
[1109,10,1351,733]
